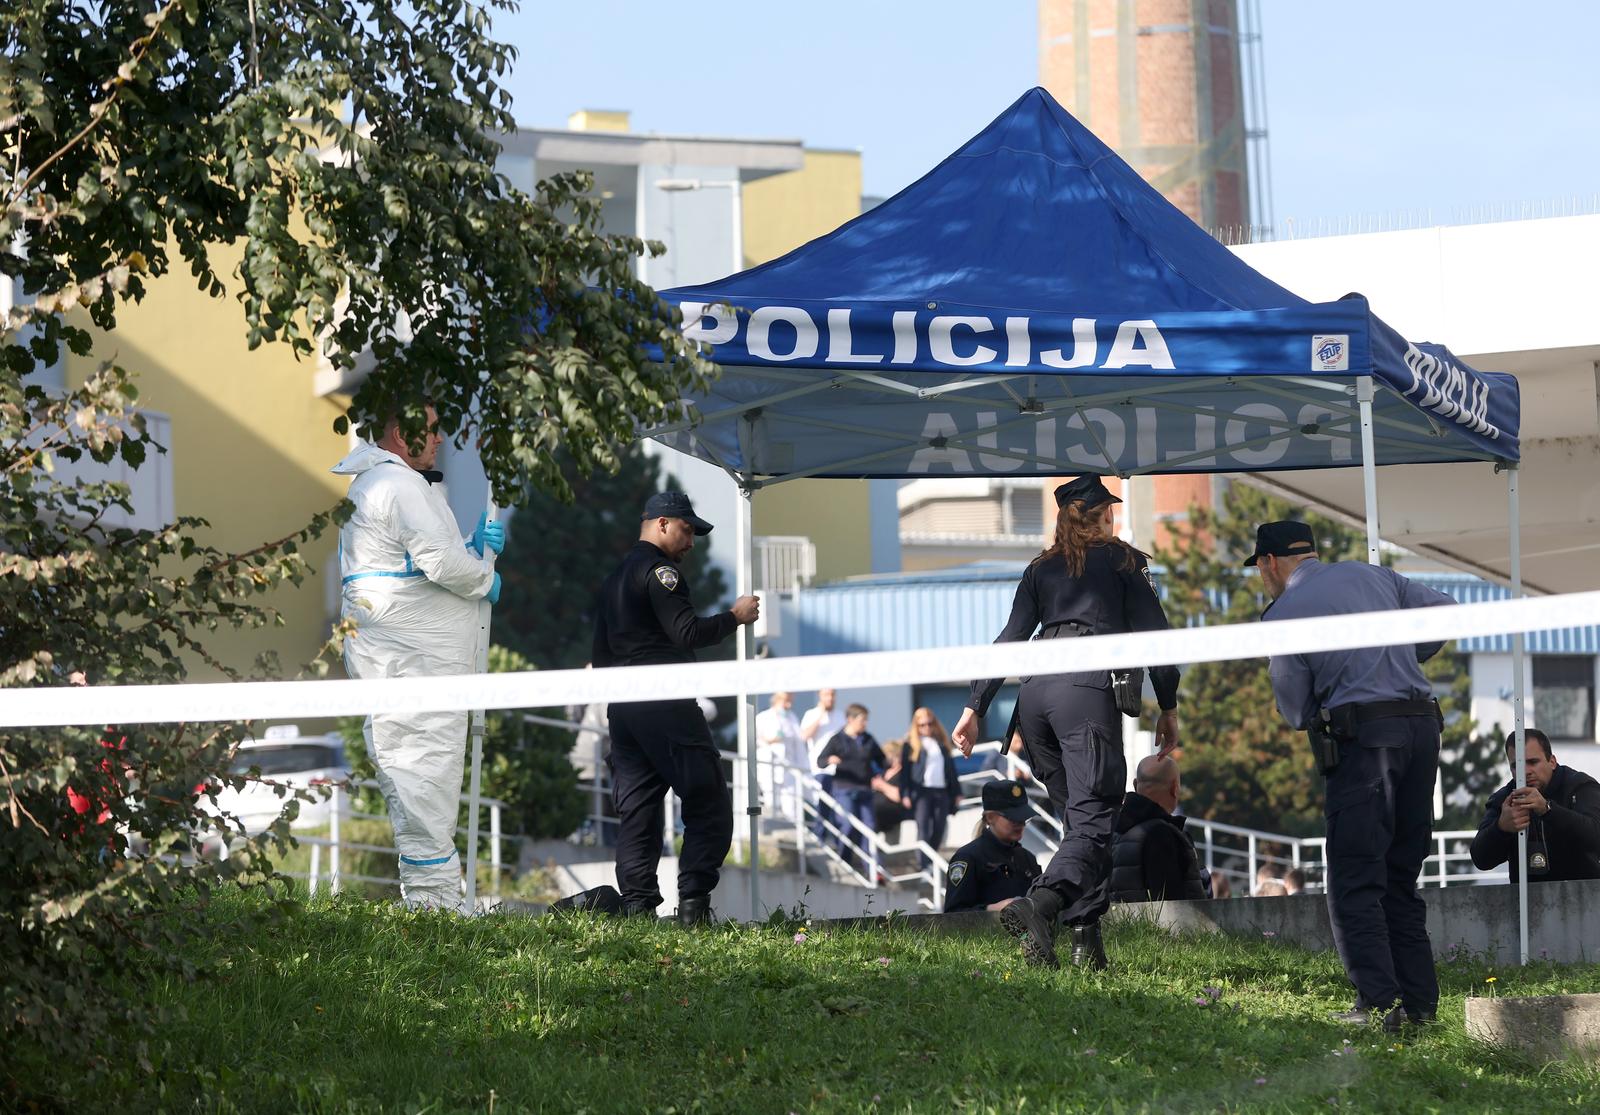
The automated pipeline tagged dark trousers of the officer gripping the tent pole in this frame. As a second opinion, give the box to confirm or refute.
[606,701,733,909]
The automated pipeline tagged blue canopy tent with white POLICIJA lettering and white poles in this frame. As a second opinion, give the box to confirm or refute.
[643,88,1526,960]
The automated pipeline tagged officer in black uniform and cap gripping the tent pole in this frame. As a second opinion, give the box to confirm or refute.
[594,491,760,925]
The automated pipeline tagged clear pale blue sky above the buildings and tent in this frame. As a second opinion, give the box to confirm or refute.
[494,0,1600,227]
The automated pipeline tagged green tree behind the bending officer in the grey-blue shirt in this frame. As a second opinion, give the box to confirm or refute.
[1154,483,1472,835]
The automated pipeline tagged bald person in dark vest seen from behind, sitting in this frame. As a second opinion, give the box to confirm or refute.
[1110,755,1211,902]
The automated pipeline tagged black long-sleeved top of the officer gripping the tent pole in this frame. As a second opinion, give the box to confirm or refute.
[590,541,739,665]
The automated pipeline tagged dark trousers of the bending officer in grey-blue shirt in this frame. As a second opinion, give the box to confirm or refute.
[1326,717,1438,1013]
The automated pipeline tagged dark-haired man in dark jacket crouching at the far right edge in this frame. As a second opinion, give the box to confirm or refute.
[1472,728,1600,883]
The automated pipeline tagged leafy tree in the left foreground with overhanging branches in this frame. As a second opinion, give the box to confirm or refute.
[0,0,710,1105]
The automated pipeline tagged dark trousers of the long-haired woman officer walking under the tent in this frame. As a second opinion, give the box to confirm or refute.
[1018,673,1128,925]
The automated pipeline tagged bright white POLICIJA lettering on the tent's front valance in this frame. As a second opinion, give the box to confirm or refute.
[682,302,1174,371]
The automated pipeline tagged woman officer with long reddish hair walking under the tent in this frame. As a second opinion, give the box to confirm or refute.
[954,477,1178,968]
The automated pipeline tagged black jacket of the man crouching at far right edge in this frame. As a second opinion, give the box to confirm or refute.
[1472,766,1600,883]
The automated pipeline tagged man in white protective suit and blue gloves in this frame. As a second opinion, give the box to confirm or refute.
[324,406,506,913]
